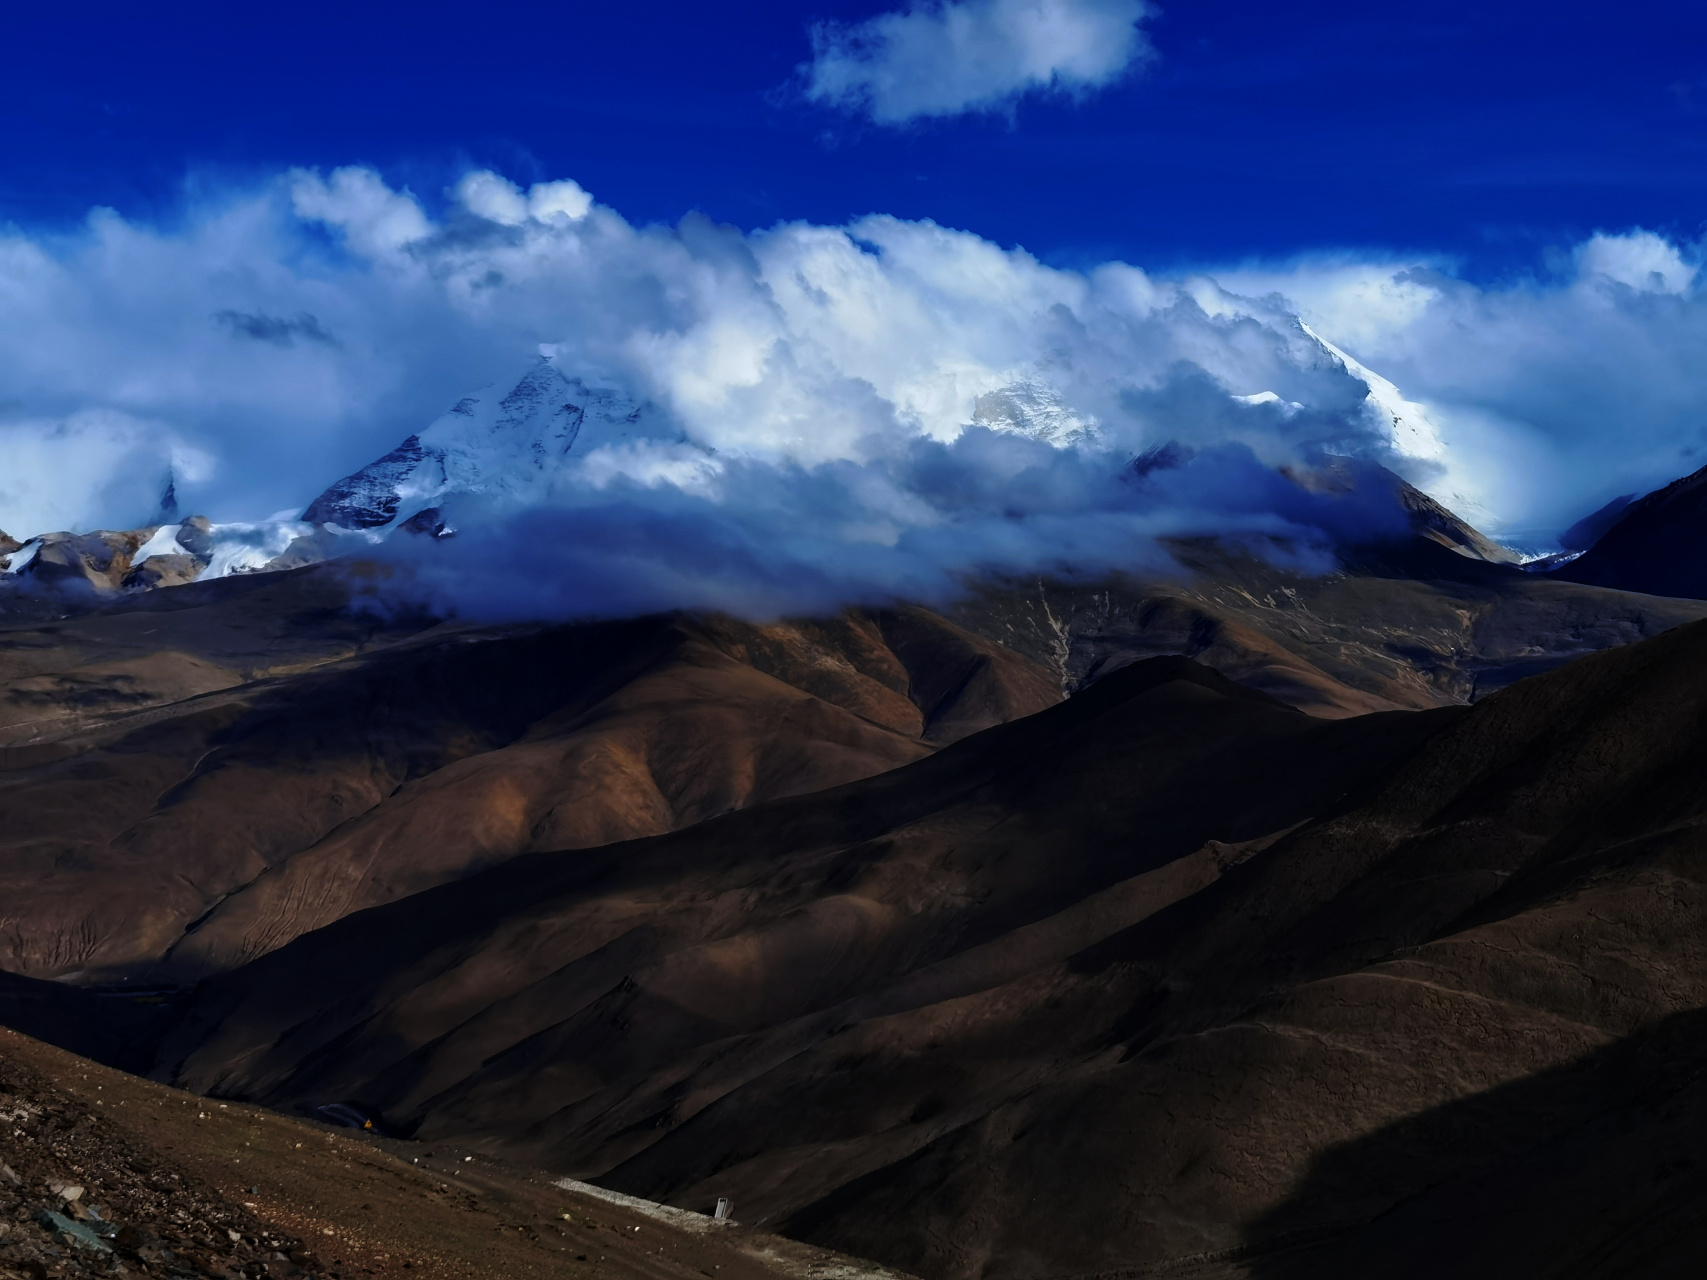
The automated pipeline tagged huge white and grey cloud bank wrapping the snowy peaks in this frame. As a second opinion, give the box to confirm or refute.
[0,169,1707,614]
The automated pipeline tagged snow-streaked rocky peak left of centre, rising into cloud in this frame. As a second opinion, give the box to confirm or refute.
[302,362,652,532]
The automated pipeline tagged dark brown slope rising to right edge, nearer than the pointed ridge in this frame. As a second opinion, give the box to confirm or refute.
[761,626,1707,1275]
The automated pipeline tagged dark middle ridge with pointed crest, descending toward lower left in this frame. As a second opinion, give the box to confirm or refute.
[146,659,1459,1217]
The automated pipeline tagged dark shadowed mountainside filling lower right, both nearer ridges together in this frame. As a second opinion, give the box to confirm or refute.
[136,625,1707,1277]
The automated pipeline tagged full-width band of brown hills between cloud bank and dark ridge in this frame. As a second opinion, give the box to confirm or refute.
[0,525,1707,981]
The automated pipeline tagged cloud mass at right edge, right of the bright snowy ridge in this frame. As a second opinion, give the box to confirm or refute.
[1219,230,1707,548]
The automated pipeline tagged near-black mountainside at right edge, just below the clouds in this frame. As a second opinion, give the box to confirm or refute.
[1552,468,1707,599]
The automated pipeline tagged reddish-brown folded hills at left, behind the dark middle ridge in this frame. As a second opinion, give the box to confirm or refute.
[0,570,1060,978]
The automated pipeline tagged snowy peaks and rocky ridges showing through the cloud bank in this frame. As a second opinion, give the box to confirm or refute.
[0,351,1516,597]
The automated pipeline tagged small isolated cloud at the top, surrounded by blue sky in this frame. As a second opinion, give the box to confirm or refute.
[801,0,1152,125]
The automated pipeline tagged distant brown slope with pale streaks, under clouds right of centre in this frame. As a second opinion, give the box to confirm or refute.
[949,539,1707,715]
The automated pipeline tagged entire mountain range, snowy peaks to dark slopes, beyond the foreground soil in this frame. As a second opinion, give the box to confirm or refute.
[0,357,1707,1280]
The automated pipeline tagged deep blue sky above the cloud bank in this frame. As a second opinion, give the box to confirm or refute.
[0,0,1707,276]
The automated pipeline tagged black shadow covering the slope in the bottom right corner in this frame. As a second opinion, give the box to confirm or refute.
[1243,1009,1707,1280]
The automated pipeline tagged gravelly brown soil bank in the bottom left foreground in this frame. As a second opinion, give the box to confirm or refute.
[0,1031,893,1280]
